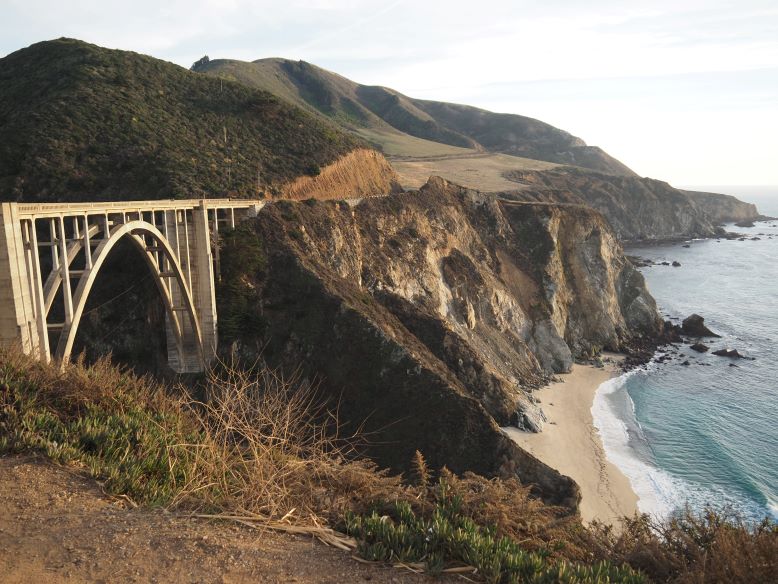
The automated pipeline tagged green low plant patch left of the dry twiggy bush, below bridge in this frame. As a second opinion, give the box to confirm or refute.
[0,358,202,506]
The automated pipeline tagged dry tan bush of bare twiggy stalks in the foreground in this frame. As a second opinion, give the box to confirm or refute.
[173,356,402,524]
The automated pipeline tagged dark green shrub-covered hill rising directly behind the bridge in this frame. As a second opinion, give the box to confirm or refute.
[0,39,364,201]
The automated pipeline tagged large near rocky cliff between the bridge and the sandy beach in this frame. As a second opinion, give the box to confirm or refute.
[220,179,660,505]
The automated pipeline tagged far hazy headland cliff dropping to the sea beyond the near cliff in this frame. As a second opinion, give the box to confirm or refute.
[506,168,736,241]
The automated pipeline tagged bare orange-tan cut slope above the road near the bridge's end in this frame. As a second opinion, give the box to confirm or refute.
[281,148,399,199]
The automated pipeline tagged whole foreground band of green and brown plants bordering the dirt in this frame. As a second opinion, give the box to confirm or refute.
[0,349,778,583]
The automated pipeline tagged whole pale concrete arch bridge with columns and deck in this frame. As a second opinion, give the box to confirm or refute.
[0,199,264,373]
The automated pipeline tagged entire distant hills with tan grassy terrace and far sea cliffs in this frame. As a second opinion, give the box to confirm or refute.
[193,59,759,240]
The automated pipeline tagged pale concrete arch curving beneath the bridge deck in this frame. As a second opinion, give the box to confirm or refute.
[54,220,203,363]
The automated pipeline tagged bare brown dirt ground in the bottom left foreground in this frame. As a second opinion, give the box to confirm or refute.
[0,457,441,584]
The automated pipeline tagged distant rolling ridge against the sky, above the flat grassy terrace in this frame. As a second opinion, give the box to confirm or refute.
[194,59,634,175]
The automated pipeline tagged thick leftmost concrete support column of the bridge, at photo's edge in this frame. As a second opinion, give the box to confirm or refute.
[0,203,42,360]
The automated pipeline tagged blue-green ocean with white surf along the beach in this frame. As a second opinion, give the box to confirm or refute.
[592,187,778,521]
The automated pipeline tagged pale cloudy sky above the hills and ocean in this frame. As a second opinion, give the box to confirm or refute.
[0,0,778,186]
